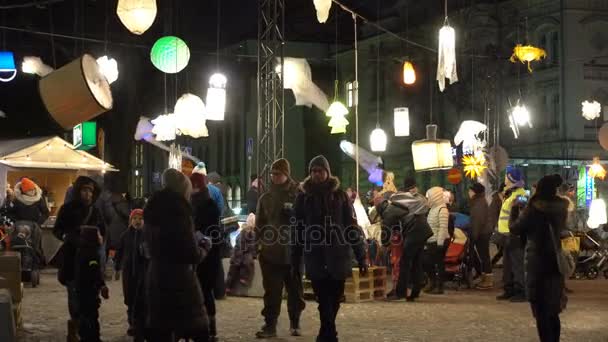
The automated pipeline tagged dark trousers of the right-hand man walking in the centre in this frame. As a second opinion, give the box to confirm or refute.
[311,277,344,342]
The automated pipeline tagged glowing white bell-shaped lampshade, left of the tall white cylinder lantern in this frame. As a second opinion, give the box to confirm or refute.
[173,94,209,138]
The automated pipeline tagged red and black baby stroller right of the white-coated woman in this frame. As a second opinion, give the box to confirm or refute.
[444,228,473,289]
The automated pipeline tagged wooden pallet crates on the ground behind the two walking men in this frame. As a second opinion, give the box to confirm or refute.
[304,267,387,303]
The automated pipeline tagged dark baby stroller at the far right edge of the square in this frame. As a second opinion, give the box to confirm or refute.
[573,230,608,279]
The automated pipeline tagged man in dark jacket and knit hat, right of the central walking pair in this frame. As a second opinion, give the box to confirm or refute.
[291,156,367,342]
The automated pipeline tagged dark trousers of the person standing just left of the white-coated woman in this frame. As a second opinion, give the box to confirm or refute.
[395,238,424,298]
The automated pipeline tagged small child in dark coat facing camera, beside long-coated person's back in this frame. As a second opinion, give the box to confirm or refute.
[114,209,146,336]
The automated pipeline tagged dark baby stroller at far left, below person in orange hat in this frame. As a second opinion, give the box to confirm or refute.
[10,221,44,287]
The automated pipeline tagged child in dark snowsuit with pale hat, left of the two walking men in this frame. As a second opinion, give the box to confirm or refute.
[226,214,257,295]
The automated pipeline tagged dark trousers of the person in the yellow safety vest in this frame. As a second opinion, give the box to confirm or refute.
[502,235,525,295]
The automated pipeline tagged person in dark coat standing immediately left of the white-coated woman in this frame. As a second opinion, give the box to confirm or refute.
[378,179,433,302]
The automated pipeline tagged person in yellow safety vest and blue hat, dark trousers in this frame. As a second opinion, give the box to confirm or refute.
[496,166,527,302]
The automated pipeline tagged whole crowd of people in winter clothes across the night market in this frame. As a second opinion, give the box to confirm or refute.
[3,156,572,342]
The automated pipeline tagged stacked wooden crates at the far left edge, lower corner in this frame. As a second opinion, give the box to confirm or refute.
[0,251,23,329]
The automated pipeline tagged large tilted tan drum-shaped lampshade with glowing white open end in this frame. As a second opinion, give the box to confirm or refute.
[38,54,112,129]
